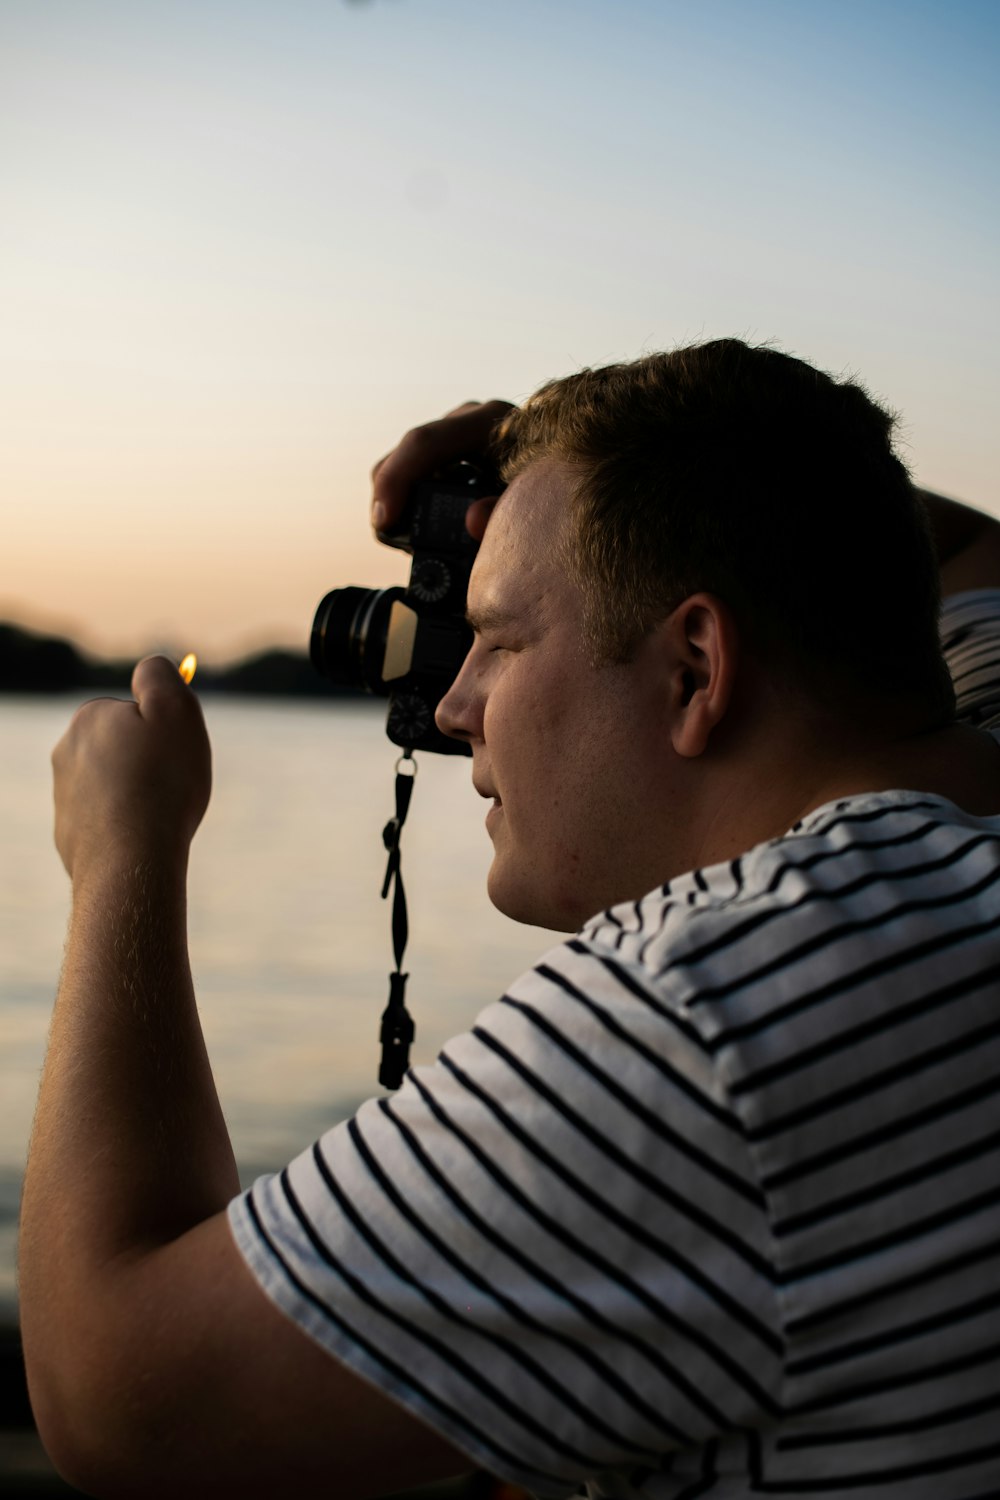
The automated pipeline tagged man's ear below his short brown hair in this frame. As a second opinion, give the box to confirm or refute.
[664,594,739,758]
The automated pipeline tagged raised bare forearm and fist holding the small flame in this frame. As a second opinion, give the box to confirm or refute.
[21,659,229,1308]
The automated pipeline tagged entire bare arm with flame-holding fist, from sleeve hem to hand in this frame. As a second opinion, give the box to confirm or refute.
[21,659,471,1500]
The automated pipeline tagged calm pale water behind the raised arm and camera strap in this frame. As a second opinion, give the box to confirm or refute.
[0,698,552,1305]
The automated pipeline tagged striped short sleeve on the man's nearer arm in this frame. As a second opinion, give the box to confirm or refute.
[231,939,781,1497]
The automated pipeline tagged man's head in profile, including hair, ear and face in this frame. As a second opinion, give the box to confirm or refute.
[438,341,952,929]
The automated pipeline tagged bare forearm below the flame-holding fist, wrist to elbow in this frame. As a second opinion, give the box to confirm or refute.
[21,861,238,1340]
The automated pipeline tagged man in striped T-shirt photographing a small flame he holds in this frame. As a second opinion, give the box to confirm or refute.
[21,341,1000,1500]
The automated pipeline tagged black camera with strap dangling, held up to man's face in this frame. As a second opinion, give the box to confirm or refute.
[310,462,501,755]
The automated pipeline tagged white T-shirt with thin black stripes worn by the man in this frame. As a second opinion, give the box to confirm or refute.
[231,591,1000,1500]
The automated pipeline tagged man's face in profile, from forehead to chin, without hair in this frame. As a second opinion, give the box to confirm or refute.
[438,459,710,930]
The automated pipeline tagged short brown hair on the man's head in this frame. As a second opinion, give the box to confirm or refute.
[498,339,954,717]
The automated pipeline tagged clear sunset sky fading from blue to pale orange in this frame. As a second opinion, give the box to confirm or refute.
[0,0,1000,662]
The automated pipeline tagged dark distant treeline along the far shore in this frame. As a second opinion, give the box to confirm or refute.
[0,623,363,698]
